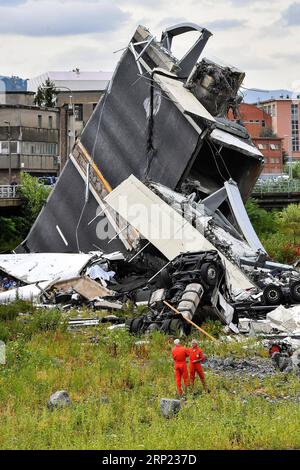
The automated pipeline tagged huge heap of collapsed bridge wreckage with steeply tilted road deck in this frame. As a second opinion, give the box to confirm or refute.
[0,23,300,334]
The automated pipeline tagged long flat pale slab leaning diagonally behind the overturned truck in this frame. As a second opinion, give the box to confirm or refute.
[105,175,254,289]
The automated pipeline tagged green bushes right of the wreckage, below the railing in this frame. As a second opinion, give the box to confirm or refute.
[246,199,300,263]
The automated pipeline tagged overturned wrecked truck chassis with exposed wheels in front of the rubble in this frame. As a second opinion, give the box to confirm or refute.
[126,251,237,336]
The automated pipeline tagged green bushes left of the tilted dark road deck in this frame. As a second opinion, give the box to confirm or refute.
[0,173,50,252]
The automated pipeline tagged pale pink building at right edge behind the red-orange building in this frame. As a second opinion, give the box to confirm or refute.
[258,97,300,160]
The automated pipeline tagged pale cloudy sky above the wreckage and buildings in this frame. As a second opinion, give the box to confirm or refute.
[0,0,300,89]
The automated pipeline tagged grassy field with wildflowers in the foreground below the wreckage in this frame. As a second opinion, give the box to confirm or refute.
[0,307,300,450]
